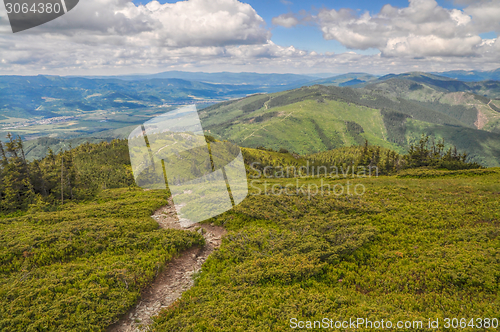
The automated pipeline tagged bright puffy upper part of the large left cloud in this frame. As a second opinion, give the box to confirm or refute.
[29,0,270,47]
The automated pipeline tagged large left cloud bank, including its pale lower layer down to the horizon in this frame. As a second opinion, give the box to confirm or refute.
[0,0,271,74]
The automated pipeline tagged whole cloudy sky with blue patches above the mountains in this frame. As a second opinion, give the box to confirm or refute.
[0,0,500,75]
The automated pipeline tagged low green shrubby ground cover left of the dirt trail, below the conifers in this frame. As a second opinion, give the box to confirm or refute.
[0,189,204,331]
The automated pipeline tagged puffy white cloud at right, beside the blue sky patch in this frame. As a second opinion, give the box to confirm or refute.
[317,0,488,57]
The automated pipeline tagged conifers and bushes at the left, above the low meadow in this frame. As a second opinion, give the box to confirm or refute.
[0,133,134,215]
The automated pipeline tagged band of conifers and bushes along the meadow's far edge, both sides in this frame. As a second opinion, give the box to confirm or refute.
[0,134,481,215]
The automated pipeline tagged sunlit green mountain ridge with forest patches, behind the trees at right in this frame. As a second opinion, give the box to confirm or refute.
[200,80,500,166]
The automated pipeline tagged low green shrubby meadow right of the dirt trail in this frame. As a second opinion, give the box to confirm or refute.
[154,169,500,331]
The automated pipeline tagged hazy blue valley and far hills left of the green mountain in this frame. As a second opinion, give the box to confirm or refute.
[0,72,313,147]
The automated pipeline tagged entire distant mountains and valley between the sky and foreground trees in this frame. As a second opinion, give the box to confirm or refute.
[0,71,500,165]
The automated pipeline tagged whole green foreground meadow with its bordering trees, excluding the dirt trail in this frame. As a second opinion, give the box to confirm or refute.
[0,139,500,332]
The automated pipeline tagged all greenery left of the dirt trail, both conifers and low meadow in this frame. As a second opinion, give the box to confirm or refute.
[0,137,204,331]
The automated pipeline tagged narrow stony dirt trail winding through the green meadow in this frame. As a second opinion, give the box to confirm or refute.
[107,199,226,332]
